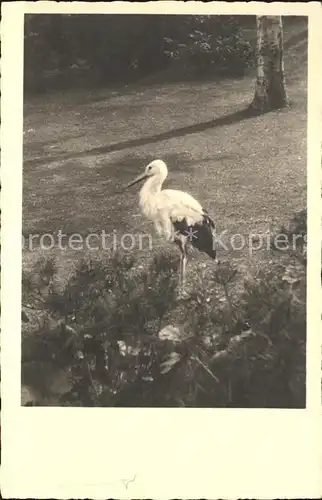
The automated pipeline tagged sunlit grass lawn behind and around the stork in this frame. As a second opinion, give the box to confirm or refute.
[23,20,307,292]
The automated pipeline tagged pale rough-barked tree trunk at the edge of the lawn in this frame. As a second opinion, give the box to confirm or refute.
[251,16,288,113]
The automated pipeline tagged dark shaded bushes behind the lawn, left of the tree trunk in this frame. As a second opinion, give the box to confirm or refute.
[24,14,256,92]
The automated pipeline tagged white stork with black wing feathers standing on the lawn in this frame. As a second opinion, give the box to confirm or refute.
[125,160,216,290]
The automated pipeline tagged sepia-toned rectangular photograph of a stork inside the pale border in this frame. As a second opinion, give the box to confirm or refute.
[21,13,308,409]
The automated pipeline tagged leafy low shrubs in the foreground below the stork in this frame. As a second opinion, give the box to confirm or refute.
[22,212,306,408]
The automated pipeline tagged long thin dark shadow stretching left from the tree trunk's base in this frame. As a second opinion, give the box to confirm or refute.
[24,108,257,166]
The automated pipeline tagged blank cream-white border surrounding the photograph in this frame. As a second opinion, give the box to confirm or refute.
[1,1,322,499]
